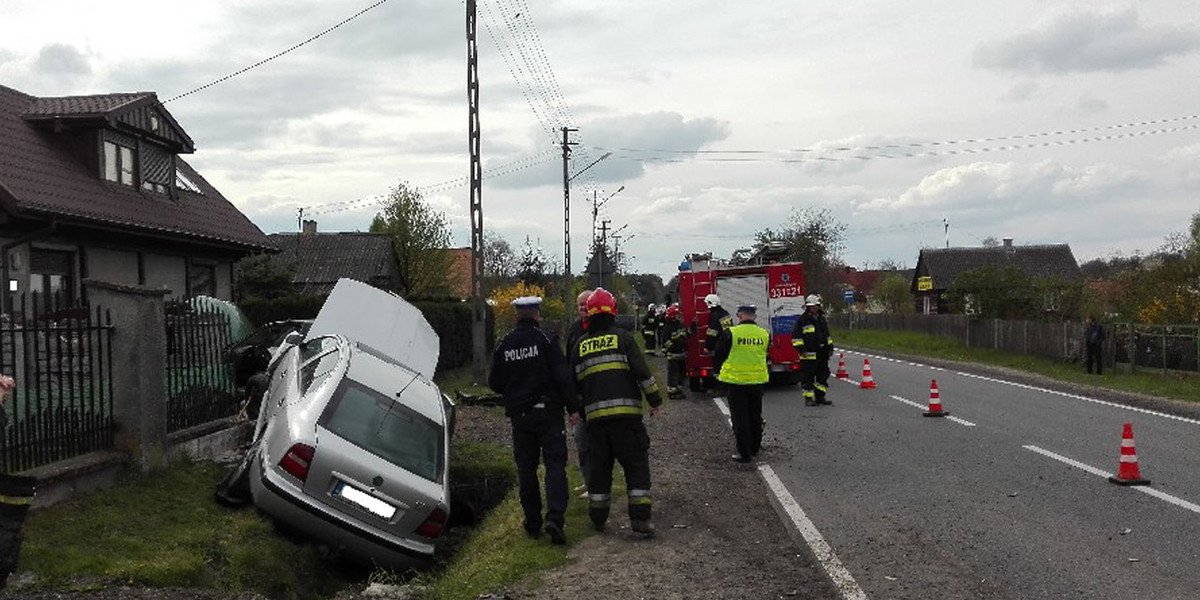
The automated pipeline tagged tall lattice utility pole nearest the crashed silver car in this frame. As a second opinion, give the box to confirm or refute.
[467,0,488,384]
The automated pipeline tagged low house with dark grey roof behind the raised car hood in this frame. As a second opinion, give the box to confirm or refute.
[269,221,400,295]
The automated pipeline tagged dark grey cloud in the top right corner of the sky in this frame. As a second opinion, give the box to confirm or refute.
[974,7,1200,73]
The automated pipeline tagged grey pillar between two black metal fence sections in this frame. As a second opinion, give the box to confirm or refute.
[83,280,170,470]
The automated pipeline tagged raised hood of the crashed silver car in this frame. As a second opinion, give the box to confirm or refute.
[306,278,438,379]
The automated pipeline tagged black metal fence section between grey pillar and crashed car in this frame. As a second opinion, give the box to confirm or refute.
[167,305,239,432]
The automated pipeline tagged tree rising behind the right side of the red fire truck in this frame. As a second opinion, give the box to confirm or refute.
[755,206,846,301]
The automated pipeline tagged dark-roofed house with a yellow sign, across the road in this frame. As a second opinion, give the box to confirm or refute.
[911,238,1080,314]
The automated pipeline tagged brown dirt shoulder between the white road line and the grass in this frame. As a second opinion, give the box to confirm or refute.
[485,372,836,600]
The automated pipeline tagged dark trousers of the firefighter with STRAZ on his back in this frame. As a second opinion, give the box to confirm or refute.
[588,418,650,526]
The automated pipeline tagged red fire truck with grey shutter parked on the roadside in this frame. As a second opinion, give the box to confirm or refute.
[679,247,804,391]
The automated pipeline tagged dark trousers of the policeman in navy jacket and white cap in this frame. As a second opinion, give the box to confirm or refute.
[512,408,568,532]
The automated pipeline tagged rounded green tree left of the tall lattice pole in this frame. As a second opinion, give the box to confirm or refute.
[371,182,452,296]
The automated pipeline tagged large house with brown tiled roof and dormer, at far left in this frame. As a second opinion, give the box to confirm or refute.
[0,85,275,312]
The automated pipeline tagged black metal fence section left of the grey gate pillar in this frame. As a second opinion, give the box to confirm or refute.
[0,298,113,473]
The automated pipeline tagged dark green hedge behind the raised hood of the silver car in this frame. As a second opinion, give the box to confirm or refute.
[239,295,496,371]
